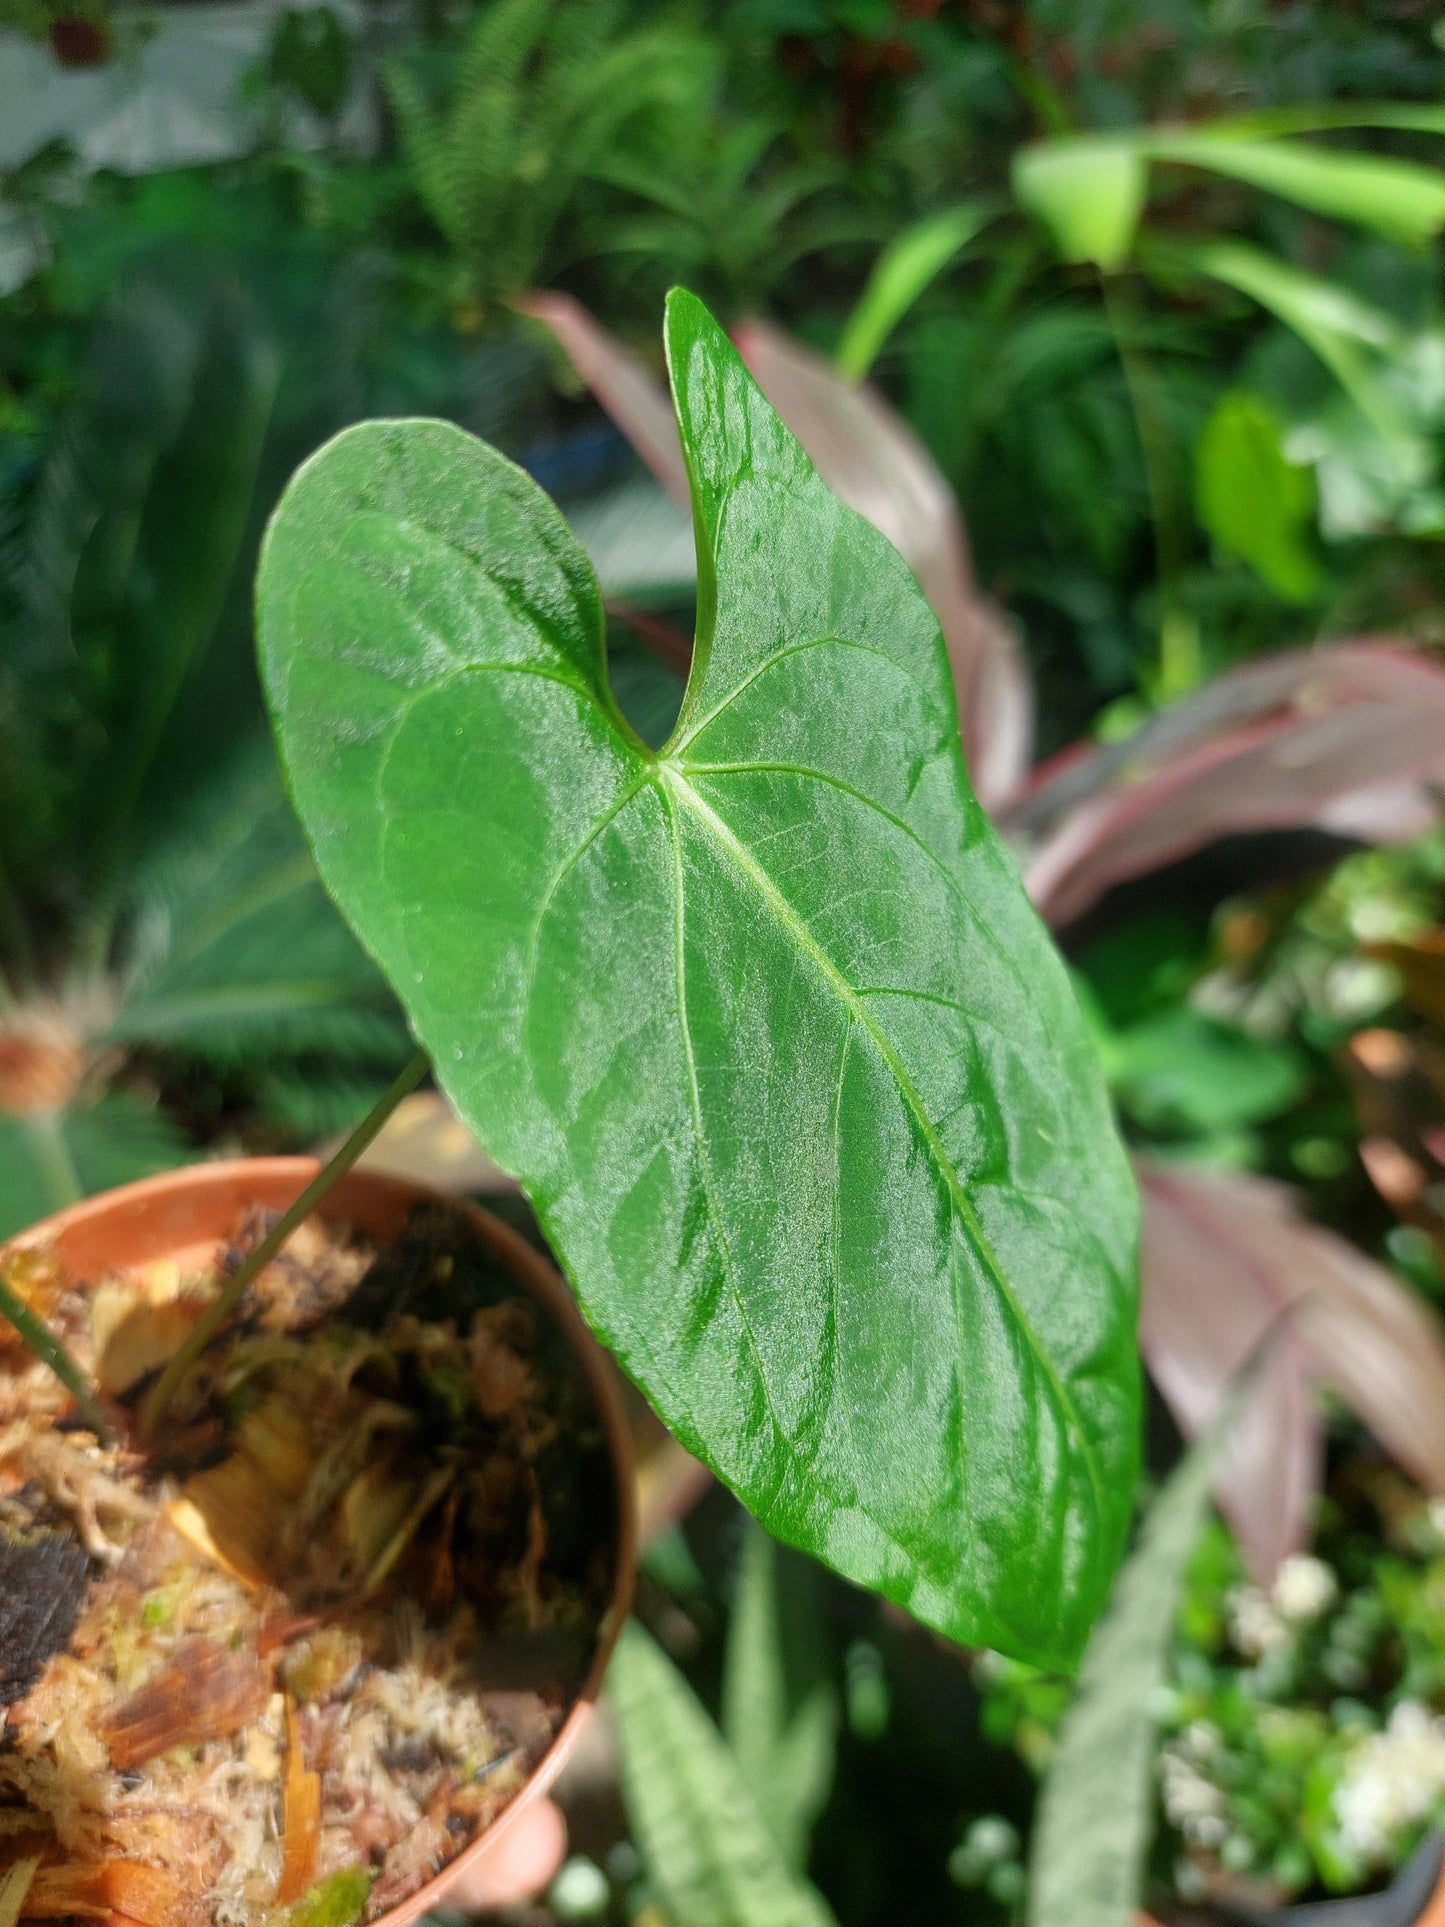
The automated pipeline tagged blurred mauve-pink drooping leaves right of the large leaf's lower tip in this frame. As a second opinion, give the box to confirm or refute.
[1139,1162,1445,1578]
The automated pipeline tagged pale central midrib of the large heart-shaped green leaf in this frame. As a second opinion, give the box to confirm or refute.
[653,757,1106,1557]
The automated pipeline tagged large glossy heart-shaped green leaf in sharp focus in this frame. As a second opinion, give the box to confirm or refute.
[260,293,1137,1663]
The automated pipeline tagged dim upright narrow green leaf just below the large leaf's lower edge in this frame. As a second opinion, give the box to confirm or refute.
[723,1522,838,1869]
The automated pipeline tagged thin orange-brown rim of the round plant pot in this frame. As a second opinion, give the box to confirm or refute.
[0,1156,638,1927]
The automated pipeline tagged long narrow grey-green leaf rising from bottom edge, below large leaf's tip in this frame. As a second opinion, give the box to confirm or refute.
[1029,1399,1235,1927]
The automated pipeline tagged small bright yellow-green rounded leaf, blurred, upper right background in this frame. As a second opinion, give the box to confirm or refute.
[1195,387,1320,603]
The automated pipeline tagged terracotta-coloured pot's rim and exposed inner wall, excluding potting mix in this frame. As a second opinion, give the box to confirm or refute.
[6,1158,636,1927]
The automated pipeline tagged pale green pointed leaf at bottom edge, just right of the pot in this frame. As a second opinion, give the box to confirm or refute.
[607,1621,832,1927]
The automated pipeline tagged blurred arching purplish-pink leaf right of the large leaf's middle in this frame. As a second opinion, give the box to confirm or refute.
[1004,642,1445,925]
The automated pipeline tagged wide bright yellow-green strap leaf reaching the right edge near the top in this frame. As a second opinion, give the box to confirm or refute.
[1144,129,1445,247]
